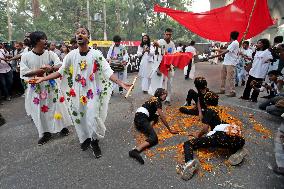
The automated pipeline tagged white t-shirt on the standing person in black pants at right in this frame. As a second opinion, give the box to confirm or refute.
[249,49,273,79]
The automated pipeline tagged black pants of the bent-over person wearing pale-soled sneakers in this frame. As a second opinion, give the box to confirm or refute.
[183,131,245,162]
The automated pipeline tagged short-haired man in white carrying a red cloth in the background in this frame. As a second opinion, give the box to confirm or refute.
[148,28,176,105]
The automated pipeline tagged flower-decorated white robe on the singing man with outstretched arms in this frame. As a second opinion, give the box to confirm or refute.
[58,49,113,143]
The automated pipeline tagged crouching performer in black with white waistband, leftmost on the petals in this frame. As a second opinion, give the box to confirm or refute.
[129,88,178,164]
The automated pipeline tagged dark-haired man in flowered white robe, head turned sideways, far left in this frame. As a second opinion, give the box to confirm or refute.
[20,32,71,145]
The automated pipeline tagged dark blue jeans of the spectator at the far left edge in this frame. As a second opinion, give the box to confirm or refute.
[0,70,13,98]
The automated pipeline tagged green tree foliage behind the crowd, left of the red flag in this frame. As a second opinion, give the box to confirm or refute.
[0,0,207,42]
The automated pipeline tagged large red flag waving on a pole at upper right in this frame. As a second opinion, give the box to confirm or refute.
[154,0,274,42]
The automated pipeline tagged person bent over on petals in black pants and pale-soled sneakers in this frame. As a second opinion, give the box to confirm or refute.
[176,124,248,180]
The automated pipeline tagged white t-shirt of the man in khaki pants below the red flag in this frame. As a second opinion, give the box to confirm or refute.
[223,40,239,66]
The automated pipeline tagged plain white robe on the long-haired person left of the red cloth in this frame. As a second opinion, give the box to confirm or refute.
[137,46,155,91]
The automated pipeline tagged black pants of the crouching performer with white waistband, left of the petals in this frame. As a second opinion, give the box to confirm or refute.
[134,112,158,147]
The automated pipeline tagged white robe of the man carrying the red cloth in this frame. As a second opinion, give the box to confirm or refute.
[148,39,175,101]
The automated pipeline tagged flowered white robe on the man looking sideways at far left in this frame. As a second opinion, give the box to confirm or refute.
[20,50,71,137]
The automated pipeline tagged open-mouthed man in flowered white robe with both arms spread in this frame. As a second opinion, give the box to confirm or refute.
[37,28,131,158]
